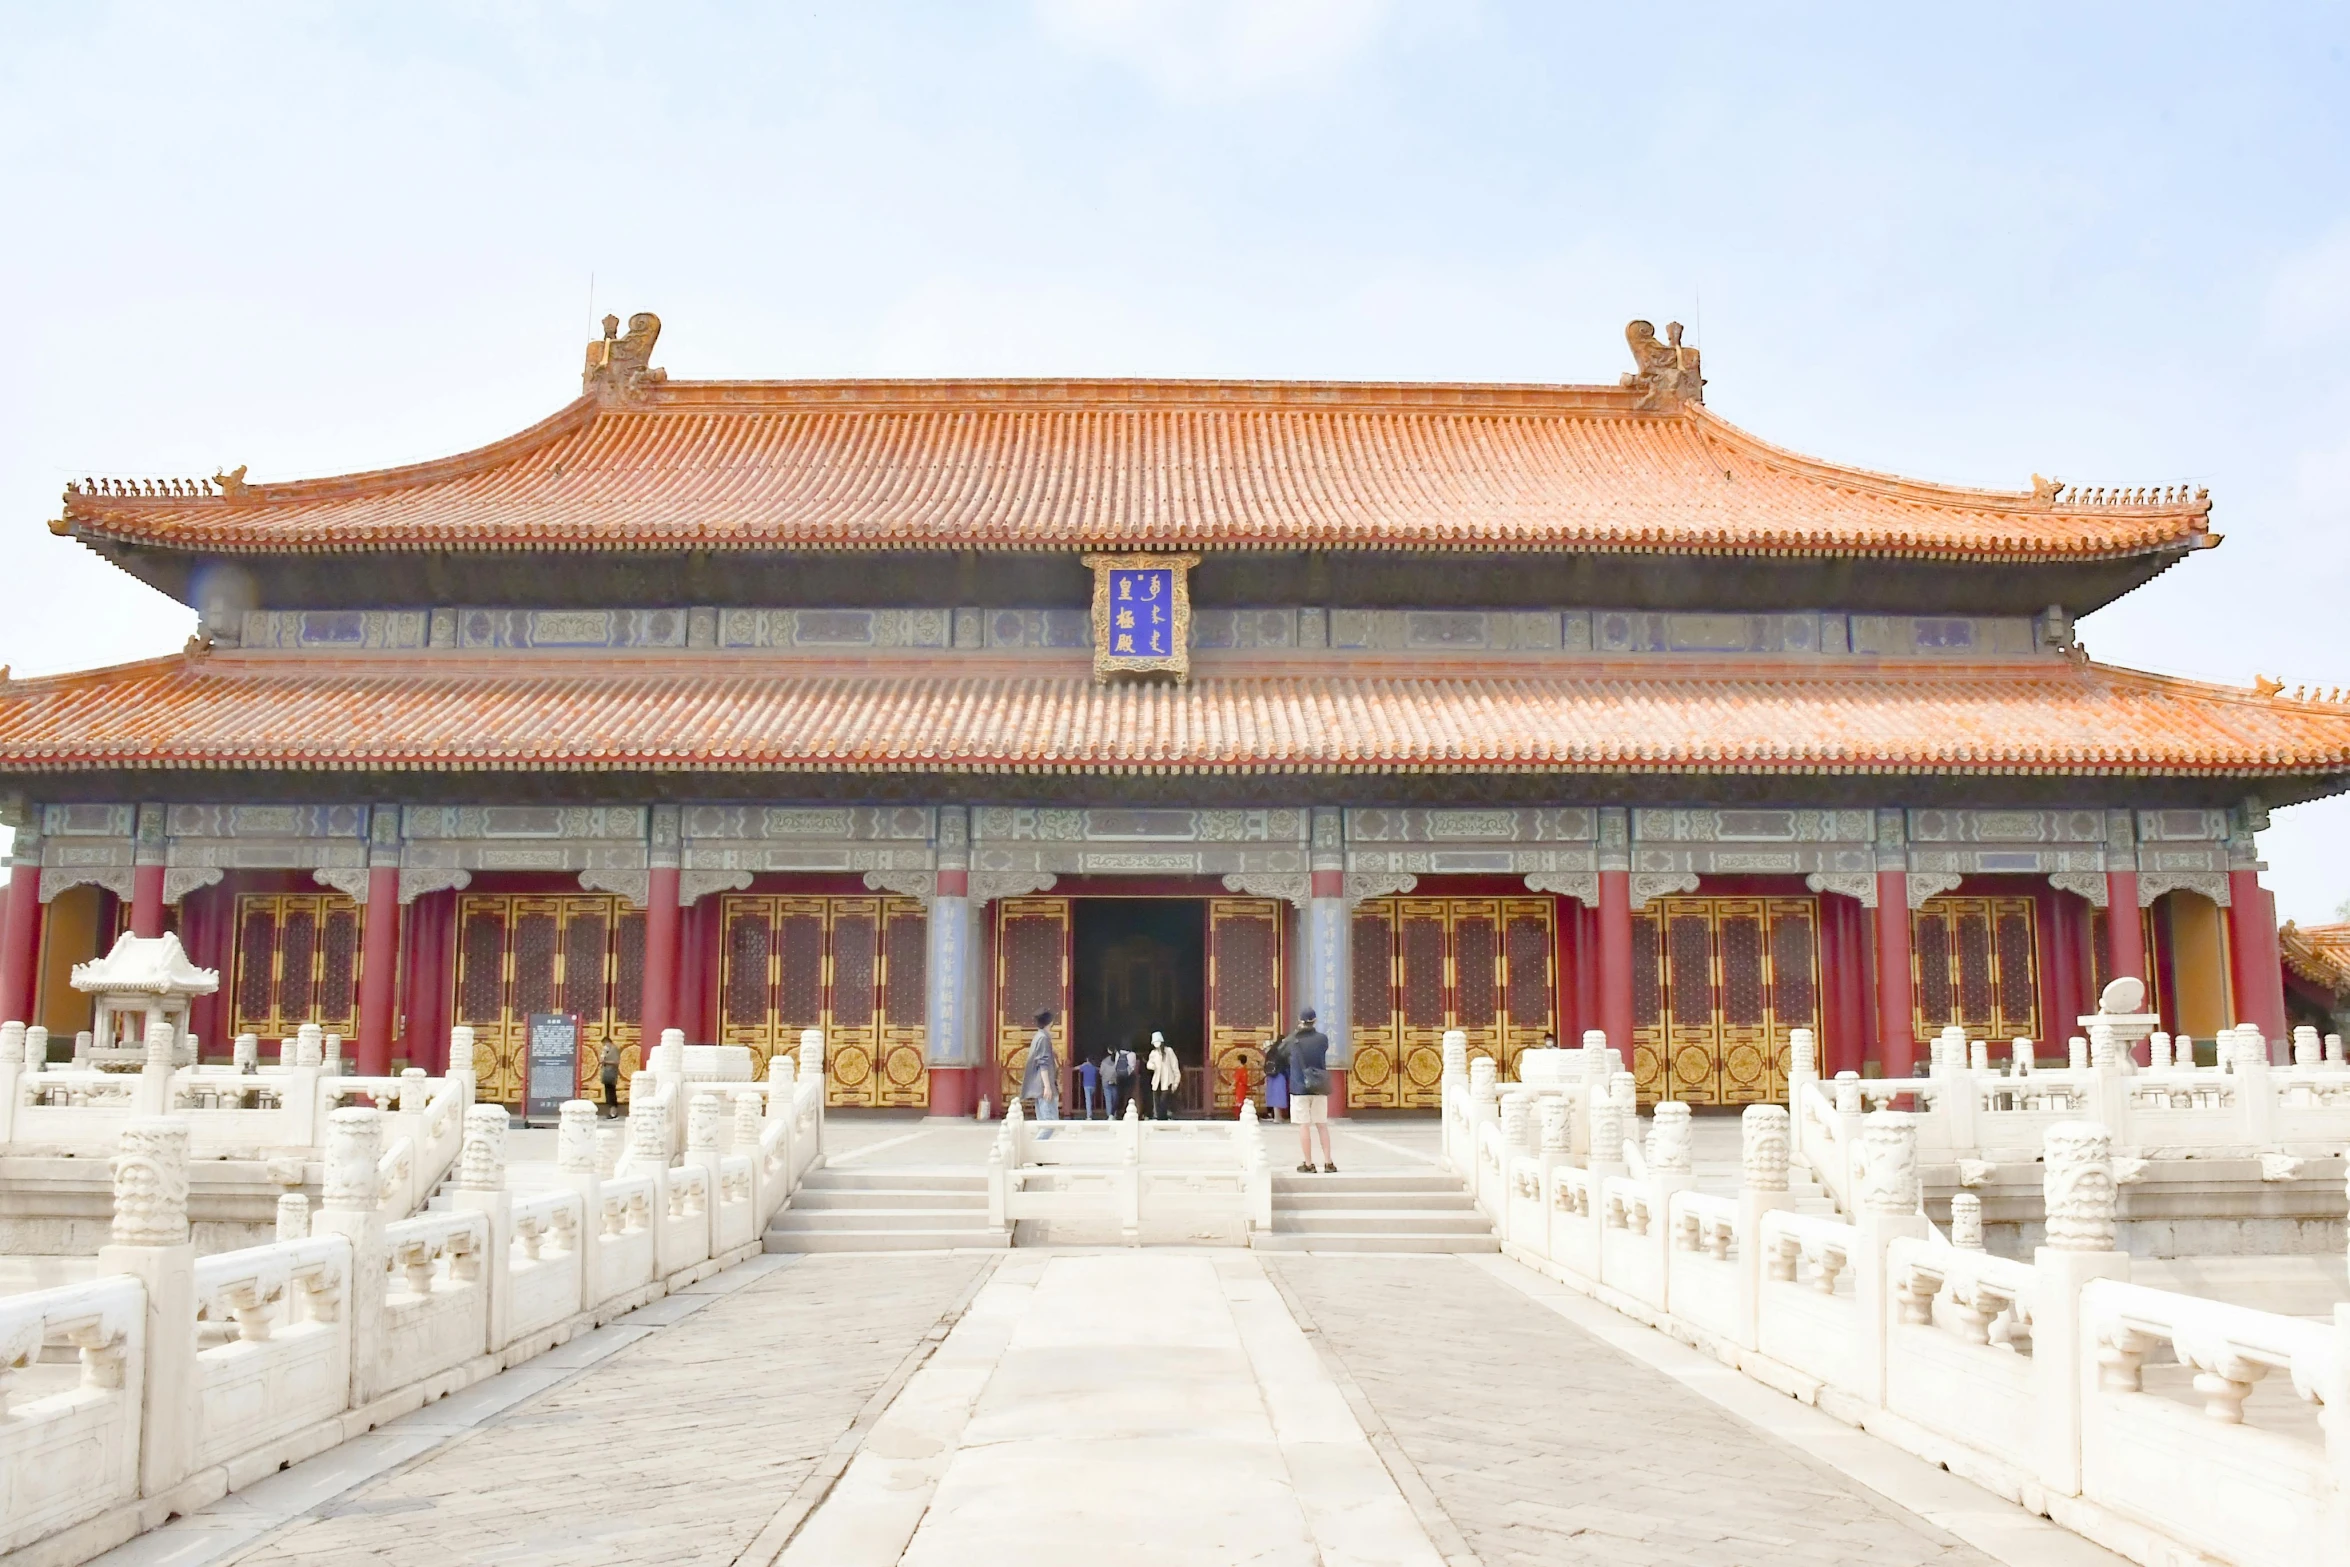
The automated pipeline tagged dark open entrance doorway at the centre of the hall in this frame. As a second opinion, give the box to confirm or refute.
[1062,897,1208,1116]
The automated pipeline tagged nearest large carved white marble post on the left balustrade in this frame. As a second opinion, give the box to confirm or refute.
[99,1122,197,1497]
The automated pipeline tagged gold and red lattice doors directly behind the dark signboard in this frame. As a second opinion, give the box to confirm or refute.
[454,893,644,1104]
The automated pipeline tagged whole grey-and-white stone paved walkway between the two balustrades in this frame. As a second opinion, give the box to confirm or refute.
[101,1121,2117,1567]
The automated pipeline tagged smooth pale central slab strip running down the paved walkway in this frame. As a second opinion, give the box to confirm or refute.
[783,1252,1443,1567]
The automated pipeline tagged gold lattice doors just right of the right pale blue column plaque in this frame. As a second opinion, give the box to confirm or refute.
[1347,897,1558,1109]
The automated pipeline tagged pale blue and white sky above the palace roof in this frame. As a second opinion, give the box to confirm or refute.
[0,0,2350,921]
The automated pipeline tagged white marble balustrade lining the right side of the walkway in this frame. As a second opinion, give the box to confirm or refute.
[1443,1041,2350,1567]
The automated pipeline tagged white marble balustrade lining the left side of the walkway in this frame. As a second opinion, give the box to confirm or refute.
[0,1038,825,1567]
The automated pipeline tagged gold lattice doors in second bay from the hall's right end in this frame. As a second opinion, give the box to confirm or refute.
[1631,897,1819,1104]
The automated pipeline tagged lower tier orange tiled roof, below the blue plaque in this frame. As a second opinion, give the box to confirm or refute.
[0,653,2350,787]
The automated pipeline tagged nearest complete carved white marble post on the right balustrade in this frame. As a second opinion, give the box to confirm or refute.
[2033,1121,2129,1497]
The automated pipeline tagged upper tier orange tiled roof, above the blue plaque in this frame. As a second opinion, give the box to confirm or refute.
[52,381,2216,561]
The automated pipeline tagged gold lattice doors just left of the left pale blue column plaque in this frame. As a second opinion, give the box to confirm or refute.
[719,893,931,1107]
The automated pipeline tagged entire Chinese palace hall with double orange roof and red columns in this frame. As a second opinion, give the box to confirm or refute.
[0,315,2350,1114]
